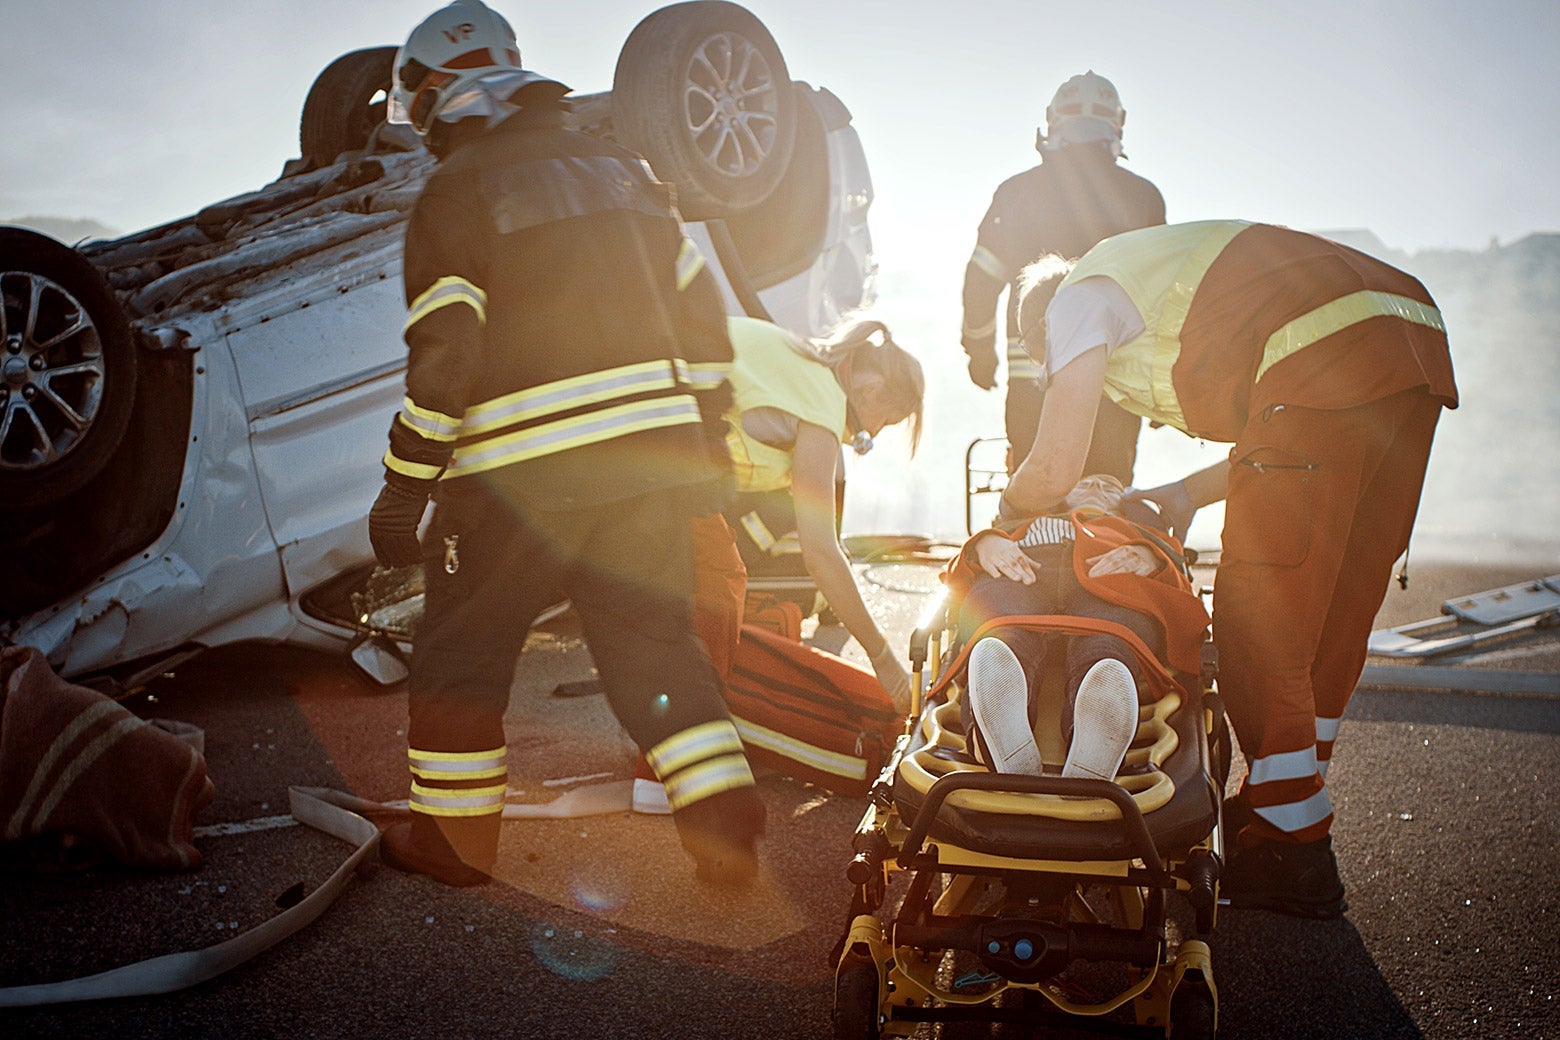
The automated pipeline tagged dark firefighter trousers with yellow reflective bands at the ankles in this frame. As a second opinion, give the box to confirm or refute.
[407,479,761,872]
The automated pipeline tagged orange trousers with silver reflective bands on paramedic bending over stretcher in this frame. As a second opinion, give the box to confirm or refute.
[1214,390,1441,844]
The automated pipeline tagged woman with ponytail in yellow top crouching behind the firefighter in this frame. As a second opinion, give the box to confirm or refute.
[633,317,925,812]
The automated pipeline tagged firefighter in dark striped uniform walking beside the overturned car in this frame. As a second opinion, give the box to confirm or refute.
[370,0,763,886]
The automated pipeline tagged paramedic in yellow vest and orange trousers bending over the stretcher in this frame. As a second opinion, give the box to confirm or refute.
[1003,220,1457,917]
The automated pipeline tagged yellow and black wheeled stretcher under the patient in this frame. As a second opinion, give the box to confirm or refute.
[833,589,1231,1040]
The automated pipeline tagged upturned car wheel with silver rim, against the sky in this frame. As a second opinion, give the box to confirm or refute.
[612,0,796,220]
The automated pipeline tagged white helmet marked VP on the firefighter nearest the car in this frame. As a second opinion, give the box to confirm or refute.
[387,0,519,136]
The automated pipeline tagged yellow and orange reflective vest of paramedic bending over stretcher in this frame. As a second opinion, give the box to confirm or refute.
[1058,220,1457,441]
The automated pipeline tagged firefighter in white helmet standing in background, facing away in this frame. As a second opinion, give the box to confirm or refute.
[963,70,1165,485]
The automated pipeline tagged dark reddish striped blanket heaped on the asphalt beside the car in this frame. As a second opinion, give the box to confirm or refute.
[0,647,215,870]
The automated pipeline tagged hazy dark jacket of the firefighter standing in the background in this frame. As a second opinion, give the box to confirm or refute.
[963,145,1165,382]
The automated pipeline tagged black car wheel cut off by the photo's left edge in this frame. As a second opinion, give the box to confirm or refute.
[0,228,136,508]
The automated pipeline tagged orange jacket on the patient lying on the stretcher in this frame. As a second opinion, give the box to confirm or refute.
[942,510,1209,675]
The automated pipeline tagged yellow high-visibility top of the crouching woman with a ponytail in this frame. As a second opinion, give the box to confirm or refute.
[727,318,849,491]
